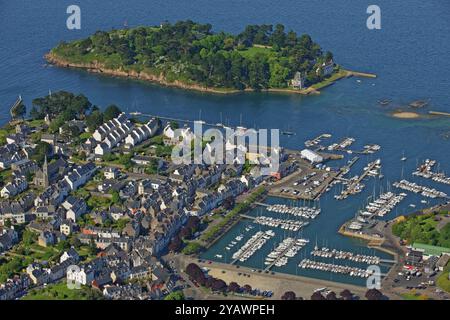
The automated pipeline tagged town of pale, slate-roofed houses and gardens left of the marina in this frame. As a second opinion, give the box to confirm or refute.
[0,92,293,299]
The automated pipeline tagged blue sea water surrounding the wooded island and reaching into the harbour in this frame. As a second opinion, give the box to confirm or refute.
[0,0,450,281]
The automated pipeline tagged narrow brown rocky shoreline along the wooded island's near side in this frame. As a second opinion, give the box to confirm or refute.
[44,51,377,95]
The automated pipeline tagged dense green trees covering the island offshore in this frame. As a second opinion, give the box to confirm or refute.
[52,21,333,90]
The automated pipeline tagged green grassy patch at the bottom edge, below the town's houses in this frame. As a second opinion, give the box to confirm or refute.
[22,281,102,300]
